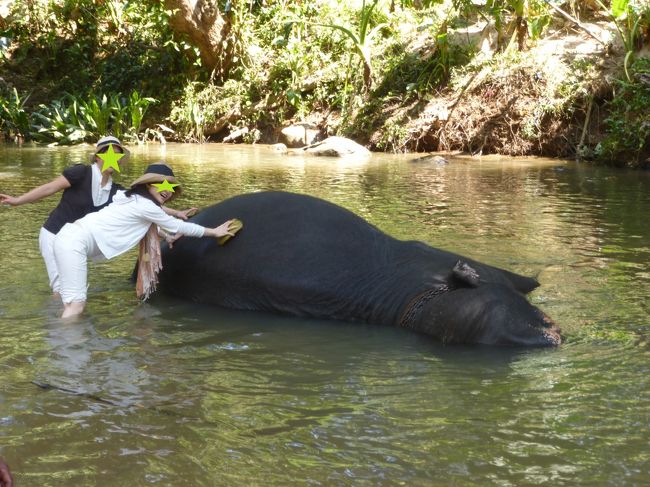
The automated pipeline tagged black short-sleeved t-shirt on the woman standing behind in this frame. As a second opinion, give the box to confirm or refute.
[43,164,124,234]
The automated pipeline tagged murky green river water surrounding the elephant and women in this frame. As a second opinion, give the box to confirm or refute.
[0,145,650,486]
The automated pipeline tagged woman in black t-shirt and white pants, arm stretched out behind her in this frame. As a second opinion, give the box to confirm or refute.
[0,136,196,295]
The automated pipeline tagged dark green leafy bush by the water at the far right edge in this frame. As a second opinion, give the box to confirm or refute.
[595,58,650,165]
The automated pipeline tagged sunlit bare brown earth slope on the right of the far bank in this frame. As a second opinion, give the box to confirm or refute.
[357,19,625,164]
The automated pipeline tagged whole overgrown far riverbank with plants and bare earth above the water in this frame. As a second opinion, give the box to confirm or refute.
[0,1,650,167]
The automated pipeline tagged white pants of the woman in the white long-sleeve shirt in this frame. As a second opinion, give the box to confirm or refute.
[54,223,101,303]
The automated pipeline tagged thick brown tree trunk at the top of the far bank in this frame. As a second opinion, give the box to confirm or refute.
[165,0,232,79]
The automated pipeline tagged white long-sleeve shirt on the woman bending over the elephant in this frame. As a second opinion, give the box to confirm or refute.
[75,191,205,259]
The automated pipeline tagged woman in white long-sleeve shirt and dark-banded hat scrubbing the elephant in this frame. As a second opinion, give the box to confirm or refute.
[54,163,234,318]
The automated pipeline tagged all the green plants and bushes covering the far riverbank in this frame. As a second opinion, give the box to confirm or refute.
[0,0,650,160]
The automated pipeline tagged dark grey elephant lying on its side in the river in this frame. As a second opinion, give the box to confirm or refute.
[159,192,560,346]
